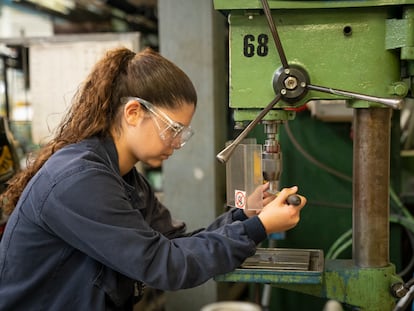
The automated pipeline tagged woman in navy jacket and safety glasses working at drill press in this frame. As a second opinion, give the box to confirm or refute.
[0,48,306,311]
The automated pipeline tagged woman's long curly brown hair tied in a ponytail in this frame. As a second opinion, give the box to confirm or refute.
[0,47,197,214]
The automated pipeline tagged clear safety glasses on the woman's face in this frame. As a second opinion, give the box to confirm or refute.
[121,97,194,148]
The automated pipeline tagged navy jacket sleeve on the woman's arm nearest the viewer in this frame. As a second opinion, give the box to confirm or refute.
[40,168,266,290]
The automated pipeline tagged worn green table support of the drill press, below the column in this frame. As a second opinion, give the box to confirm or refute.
[216,260,402,311]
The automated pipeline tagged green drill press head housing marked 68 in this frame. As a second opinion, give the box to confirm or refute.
[225,7,400,116]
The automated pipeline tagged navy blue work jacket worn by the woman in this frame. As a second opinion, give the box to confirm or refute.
[0,138,266,311]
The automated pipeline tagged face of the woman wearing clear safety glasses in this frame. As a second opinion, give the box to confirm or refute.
[118,100,195,172]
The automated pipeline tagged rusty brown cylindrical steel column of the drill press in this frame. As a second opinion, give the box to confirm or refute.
[353,108,391,267]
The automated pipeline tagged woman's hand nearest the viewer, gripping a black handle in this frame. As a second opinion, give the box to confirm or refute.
[258,186,306,234]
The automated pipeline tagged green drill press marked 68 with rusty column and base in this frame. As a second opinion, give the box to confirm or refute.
[214,0,414,311]
